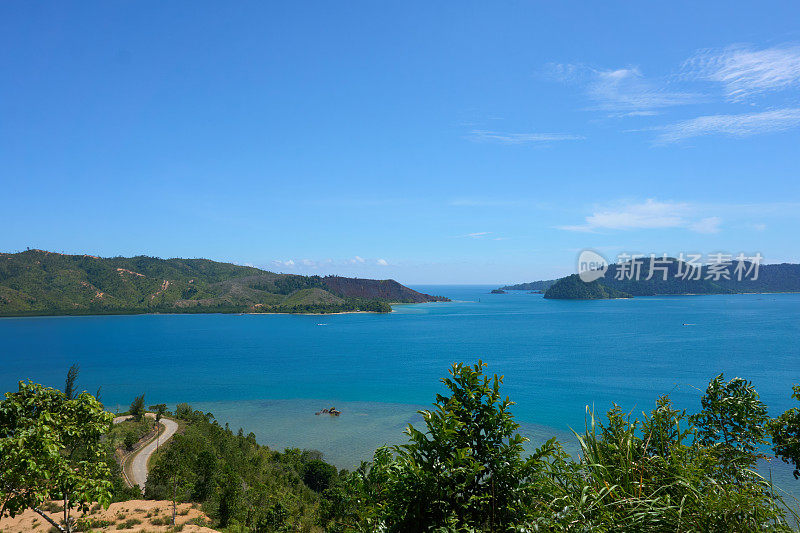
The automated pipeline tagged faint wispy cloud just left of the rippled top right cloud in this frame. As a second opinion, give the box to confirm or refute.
[546,64,703,116]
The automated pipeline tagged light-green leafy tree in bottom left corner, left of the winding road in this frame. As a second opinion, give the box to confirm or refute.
[0,382,113,531]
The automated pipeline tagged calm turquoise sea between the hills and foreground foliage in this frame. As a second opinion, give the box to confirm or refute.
[0,286,800,498]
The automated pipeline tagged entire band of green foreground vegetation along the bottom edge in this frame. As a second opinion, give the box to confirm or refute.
[0,363,800,533]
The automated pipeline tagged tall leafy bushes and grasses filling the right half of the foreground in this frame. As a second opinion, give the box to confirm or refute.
[322,364,796,532]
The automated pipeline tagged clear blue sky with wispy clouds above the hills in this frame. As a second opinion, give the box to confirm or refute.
[0,1,800,284]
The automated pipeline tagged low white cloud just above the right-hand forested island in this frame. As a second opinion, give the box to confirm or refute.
[559,199,722,233]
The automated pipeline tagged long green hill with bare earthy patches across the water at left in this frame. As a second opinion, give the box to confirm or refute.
[0,250,447,316]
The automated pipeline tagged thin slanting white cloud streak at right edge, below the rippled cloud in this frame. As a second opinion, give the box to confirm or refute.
[653,108,800,144]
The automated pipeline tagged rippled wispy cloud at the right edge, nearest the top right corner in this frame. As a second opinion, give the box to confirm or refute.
[683,45,800,101]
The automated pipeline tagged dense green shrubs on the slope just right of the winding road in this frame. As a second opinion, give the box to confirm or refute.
[145,404,338,532]
